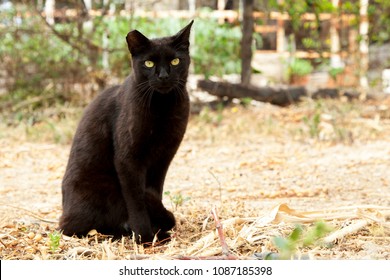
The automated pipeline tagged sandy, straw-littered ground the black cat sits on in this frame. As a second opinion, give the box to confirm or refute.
[0,99,390,259]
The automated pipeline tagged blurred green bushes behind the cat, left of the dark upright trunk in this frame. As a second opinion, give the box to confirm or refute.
[0,5,241,118]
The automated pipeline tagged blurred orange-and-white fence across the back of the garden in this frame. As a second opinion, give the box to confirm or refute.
[39,6,362,86]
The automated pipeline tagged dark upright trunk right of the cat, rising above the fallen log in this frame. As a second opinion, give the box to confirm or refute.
[241,0,254,86]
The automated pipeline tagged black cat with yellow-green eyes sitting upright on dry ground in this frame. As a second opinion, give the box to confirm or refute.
[59,21,193,243]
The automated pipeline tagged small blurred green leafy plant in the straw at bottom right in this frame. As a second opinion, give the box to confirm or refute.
[270,221,332,260]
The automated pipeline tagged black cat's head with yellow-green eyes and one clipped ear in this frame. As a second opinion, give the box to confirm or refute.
[126,21,193,93]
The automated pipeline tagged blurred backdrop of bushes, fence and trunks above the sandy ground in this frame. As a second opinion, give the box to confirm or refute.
[0,0,390,136]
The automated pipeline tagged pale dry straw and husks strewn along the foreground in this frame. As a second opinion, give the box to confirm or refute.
[0,201,390,260]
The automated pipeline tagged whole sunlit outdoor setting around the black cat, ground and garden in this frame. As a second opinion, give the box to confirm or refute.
[0,0,390,260]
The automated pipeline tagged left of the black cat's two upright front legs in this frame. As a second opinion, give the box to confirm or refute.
[115,160,154,243]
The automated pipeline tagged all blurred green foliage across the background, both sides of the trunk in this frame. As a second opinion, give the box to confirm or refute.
[0,0,390,120]
